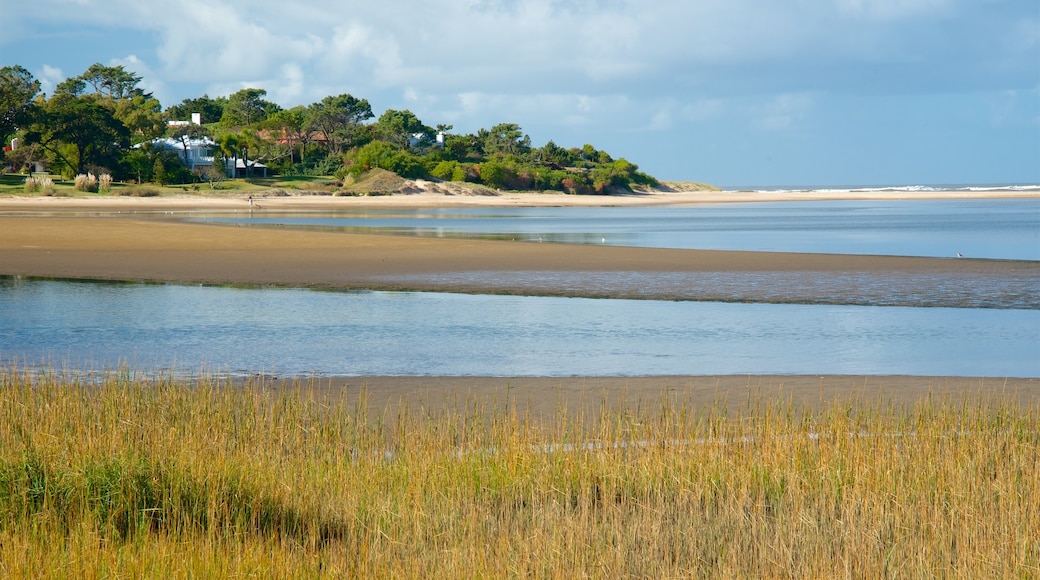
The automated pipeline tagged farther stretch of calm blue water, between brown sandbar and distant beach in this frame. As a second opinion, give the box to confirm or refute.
[196,199,1040,260]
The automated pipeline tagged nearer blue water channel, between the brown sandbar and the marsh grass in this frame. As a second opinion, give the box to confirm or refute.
[0,278,1040,376]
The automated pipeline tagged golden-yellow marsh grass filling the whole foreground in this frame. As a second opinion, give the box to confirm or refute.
[0,368,1040,578]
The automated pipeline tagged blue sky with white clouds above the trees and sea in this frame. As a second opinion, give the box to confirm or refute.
[0,0,1040,187]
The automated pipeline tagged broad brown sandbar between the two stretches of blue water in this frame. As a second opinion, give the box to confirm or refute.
[0,217,1040,304]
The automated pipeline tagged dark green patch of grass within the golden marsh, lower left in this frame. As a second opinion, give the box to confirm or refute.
[0,455,345,542]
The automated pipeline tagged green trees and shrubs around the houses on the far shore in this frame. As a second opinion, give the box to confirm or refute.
[0,63,657,193]
